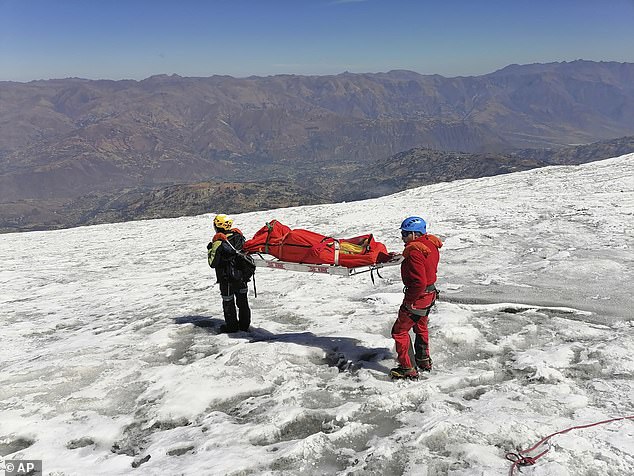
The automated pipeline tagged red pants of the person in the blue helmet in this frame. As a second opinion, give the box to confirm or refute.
[392,303,433,368]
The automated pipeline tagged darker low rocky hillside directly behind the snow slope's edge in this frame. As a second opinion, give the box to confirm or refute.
[0,136,634,232]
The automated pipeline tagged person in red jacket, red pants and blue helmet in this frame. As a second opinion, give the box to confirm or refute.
[390,217,442,378]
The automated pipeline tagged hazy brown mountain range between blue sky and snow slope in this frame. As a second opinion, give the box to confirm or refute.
[0,61,634,231]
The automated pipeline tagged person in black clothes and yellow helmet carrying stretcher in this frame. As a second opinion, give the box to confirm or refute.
[207,215,251,332]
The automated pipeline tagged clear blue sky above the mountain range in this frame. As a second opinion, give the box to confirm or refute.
[0,0,634,81]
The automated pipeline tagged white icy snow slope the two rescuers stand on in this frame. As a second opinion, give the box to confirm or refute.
[0,154,634,476]
